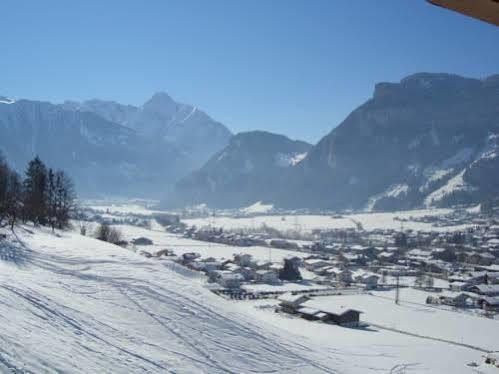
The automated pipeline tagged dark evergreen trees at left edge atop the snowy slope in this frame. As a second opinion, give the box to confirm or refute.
[0,154,76,229]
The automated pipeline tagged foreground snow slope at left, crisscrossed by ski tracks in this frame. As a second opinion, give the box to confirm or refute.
[0,228,336,373]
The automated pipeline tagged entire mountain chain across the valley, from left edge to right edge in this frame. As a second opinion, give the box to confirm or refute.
[0,73,499,210]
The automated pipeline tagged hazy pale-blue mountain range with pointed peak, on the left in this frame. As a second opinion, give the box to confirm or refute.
[0,93,232,197]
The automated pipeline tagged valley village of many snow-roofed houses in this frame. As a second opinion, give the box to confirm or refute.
[156,211,499,319]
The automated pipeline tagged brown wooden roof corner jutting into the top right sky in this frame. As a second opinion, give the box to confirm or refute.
[427,0,499,26]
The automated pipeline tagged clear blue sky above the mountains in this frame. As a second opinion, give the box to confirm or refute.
[0,0,499,142]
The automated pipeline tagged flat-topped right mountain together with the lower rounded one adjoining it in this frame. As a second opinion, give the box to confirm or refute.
[165,73,499,210]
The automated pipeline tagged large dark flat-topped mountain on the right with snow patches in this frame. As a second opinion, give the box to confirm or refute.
[290,73,499,210]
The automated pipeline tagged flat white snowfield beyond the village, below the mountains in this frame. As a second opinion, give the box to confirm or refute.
[183,209,474,232]
